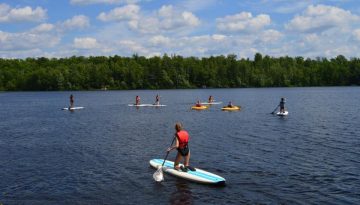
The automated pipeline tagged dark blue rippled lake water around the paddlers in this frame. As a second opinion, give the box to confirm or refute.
[0,87,360,204]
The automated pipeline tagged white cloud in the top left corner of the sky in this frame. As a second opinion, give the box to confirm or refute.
[0,4,47,23]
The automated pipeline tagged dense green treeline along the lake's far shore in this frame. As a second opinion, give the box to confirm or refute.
[0,53,360,91]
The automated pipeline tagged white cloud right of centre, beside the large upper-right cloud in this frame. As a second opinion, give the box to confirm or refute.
[216,12,271,33]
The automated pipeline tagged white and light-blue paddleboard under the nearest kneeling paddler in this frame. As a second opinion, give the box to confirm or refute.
[150,159,225,184]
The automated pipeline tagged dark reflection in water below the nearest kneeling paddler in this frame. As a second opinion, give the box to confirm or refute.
[169,179,194,205]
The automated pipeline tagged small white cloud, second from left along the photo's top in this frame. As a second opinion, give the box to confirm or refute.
[97,4,140,21]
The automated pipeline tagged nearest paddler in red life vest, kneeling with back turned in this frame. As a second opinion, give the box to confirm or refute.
[167,122,196,172]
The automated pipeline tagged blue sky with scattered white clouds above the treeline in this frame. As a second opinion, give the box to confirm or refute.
[0,0,360,58]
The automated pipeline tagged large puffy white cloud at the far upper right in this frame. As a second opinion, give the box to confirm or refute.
[285,5,360,33]
